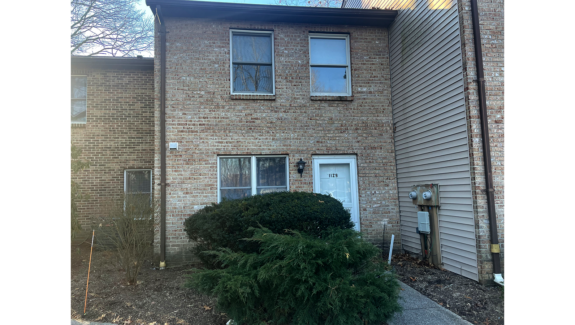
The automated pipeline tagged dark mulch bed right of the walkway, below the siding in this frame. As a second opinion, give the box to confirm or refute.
[391,254,505,325]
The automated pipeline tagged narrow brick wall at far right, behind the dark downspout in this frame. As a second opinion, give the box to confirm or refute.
[458,0,505,281]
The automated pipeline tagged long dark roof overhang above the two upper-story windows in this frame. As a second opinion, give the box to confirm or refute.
[146,0,397,27]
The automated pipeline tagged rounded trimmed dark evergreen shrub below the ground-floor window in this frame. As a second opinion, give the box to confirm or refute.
[184,192,353,267]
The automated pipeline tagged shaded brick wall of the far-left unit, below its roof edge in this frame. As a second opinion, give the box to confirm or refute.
[70,66,154,230]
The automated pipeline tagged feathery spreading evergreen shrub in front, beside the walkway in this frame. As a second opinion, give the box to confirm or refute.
[186,228,401,325]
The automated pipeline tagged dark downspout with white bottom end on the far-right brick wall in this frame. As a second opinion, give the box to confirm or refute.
[471,0,505,286]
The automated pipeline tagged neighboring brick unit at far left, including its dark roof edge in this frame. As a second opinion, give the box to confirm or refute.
[70,56,154,233]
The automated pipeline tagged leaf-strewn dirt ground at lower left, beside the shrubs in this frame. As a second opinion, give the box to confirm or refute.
[70,244,229,325]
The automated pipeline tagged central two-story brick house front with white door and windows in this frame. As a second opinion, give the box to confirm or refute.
[148,1,399,263]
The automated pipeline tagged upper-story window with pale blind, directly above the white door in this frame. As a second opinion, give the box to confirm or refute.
[309,33,351,96]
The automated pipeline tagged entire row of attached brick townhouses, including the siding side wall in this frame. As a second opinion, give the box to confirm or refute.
[70,0,505,282]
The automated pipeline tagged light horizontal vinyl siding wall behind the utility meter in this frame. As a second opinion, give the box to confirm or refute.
[382,0,478,281]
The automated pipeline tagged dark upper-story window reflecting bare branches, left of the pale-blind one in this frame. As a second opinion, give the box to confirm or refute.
[230,30,275,95]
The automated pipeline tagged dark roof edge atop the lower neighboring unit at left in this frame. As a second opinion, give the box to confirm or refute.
[70,56,154,70]
